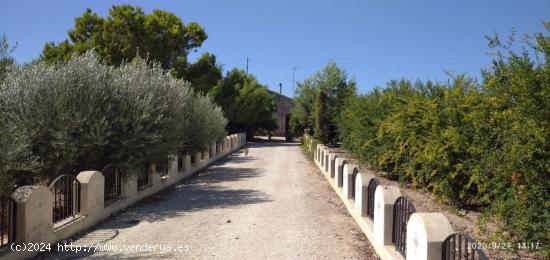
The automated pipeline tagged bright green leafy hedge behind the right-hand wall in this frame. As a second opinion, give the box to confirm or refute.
[338,35,550,252]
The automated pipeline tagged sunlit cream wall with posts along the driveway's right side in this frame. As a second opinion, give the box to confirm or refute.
[304,135,466,260]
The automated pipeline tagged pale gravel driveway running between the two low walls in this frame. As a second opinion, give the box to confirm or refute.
[39,142,377,259]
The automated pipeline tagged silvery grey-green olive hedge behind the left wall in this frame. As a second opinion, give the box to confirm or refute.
[0,52,226,190]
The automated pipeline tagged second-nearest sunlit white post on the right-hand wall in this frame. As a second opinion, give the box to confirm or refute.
[374,185,401,246]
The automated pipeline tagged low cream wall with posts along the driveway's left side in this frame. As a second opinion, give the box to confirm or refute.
[0,133,246,259]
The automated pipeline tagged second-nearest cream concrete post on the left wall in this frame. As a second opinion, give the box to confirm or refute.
[76,171,105,216]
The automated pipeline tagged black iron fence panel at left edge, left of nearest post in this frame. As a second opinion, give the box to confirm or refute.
[0,195,17,247]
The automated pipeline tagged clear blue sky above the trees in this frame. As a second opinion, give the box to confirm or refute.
[0,0,550,95]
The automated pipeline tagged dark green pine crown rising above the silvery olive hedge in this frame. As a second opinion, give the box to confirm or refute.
[41,5,207,69]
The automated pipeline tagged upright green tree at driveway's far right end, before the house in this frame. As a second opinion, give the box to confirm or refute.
[290,61,356,142]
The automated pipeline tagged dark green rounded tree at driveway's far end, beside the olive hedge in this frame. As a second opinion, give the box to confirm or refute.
[210,69,276,136]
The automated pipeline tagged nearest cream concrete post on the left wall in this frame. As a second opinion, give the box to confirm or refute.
[11,185,54,243]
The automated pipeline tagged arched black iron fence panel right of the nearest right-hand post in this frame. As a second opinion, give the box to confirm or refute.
[441,233,488,260]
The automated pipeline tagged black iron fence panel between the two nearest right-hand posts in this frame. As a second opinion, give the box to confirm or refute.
[392,196,416,257]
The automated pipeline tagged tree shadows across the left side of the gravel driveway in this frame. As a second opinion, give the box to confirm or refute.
[36,154,272,259]
